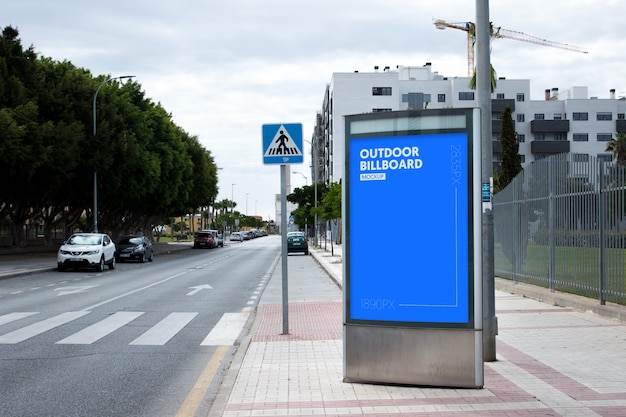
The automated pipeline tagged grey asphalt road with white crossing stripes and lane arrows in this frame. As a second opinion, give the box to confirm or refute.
[0,236,280,417]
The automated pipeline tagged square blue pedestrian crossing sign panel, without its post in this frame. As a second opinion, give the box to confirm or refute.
[263,123,304,165]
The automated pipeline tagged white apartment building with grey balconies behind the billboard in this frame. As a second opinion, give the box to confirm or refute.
[313,63,626,183]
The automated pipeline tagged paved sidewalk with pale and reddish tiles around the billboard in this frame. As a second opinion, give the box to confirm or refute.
[209,242,626,417]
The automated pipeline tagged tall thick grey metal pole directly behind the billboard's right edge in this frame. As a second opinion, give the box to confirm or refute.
[475,0,498,362]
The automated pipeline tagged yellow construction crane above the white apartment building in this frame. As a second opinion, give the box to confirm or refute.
[434,19,587,77]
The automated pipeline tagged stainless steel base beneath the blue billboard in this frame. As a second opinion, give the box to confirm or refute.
[343,324,484,388]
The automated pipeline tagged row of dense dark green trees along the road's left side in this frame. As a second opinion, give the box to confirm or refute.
[0,26,217,245]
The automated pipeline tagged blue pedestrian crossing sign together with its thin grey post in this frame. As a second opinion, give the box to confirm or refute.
[262,123,304,334]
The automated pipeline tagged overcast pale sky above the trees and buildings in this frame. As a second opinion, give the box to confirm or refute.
[0,0,626,219]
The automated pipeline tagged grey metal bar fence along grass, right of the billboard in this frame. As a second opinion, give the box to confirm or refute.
[493,154,626,305]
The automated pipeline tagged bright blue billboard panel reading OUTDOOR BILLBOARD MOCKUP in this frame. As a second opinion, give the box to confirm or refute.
[346,131,474,327]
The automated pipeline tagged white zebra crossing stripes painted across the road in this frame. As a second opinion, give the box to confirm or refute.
[0,309,250,346]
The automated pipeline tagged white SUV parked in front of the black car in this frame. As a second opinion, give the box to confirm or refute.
[57,233,115,272]
